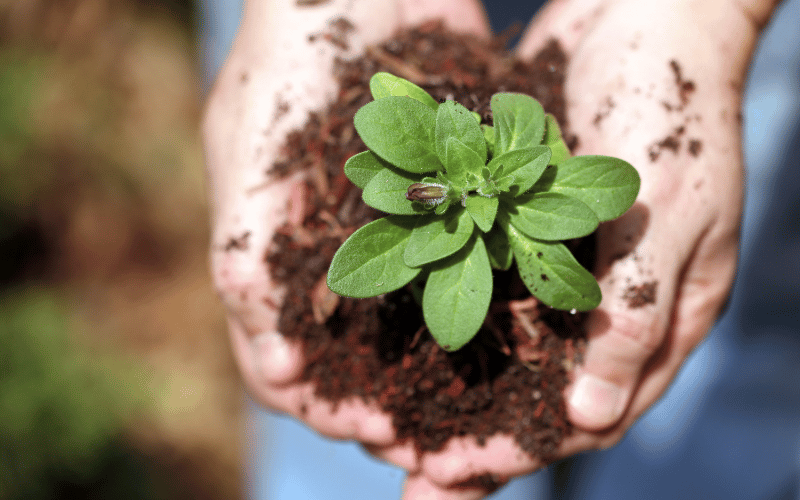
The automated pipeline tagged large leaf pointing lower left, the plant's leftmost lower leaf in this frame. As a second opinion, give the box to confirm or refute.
[328,216,420,298]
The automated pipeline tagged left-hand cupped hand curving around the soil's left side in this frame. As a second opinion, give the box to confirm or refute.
[203,0,489,484]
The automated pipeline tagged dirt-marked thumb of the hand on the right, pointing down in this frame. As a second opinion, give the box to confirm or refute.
[567,221,684,430]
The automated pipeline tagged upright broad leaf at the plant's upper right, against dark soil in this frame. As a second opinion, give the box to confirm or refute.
[491,93,544,155]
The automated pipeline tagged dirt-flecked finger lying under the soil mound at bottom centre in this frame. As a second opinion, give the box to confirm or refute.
[422,435,542,487]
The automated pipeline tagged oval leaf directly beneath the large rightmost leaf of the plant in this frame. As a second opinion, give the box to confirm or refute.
[504,193,599,241]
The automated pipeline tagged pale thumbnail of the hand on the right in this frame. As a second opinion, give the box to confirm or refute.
[569,374,624,428]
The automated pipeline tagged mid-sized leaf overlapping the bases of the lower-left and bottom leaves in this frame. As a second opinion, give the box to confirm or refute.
[403,207,475,267]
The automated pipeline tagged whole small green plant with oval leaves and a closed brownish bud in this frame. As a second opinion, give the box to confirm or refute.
[327,73,640,351]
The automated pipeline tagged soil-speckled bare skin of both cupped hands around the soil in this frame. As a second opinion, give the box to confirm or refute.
[203,0,777,500]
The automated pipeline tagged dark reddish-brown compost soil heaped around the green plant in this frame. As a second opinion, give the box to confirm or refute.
[265,23,594,459]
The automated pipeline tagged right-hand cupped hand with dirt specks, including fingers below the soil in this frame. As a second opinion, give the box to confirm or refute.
[384,0,776,499]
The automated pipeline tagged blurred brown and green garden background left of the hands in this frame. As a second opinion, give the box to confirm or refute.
[0,0,244,500]
